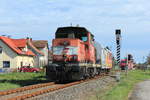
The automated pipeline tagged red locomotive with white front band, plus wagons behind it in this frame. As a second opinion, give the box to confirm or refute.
[46,26,112,81]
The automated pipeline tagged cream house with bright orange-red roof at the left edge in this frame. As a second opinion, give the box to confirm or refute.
[0,36,36,69]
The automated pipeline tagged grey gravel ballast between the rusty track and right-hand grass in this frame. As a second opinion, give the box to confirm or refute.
[28,76,116,100]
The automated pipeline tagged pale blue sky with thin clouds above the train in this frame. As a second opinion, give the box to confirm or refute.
[0,0,150,62]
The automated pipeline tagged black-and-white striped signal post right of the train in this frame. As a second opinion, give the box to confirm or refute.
[115,29,121,66]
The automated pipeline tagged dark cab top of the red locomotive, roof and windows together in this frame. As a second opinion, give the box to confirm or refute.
[56,27,88,42]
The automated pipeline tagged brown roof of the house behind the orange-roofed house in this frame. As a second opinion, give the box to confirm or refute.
[32,40,48,48]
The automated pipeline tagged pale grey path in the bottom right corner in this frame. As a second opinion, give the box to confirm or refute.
[129,80,150,100]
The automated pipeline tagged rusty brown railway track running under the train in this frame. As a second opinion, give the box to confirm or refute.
[0,74,107,100]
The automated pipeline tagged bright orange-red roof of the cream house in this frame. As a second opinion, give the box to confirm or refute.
[0,36,35,56]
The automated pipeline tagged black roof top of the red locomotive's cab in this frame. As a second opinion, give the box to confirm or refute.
[56,26,94,36]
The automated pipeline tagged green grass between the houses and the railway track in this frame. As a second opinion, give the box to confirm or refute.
[0,72,47,91]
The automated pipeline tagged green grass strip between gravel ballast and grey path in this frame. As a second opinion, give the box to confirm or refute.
[88,70,150,100]
